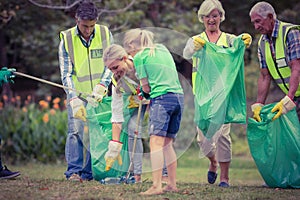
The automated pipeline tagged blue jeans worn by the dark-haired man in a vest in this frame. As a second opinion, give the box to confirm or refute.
[64,103,93,180]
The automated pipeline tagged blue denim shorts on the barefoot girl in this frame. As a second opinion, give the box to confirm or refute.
[149,93,184,138]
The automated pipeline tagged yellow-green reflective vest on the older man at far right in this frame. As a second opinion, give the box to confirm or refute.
[258,22,300,97]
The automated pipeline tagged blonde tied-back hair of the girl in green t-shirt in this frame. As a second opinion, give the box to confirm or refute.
[123,28,155,55]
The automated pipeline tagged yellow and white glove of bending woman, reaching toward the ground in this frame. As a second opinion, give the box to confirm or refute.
[104,140,123,171]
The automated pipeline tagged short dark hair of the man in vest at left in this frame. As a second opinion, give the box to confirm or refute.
[75,1,98,20]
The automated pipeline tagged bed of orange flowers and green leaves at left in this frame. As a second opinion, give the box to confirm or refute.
[0,96,67,162]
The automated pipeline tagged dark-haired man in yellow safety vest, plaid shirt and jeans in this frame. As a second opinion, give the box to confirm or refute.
[59,1,112,181]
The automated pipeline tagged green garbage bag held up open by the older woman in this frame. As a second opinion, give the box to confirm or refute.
[194,36,247,139]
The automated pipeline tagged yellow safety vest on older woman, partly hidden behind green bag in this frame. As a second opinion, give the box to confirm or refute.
[192,32,235,94]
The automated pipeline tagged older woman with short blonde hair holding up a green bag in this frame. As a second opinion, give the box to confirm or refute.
[183,0,252,187]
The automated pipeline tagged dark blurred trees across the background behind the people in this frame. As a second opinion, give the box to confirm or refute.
[0,0,300,101]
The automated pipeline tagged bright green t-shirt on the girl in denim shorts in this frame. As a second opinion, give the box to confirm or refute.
[133,44,183,98]
